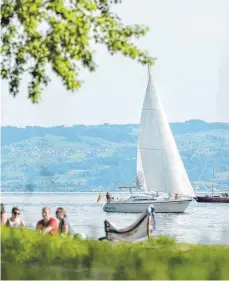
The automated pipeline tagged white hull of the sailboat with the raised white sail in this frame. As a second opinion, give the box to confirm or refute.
[103,199,192,213]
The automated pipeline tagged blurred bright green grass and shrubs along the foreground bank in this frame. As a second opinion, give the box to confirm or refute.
[2,226,229,280]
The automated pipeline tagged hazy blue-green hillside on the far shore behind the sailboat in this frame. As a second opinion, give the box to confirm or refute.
[1,120,229,191]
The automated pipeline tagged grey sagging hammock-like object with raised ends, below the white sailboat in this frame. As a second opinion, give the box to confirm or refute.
[104,205,156,242]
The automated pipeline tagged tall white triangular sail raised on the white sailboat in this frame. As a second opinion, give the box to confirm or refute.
[137,66,195,197]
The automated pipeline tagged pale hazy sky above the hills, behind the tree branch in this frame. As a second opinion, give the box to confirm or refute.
[2,0,229,126]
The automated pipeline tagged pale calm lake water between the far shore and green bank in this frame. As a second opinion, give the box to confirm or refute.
[1,193,229,245]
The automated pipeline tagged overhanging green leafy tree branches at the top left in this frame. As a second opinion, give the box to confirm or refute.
[1,0,153,103]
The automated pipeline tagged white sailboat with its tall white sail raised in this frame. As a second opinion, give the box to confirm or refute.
[103,68,196,213]
